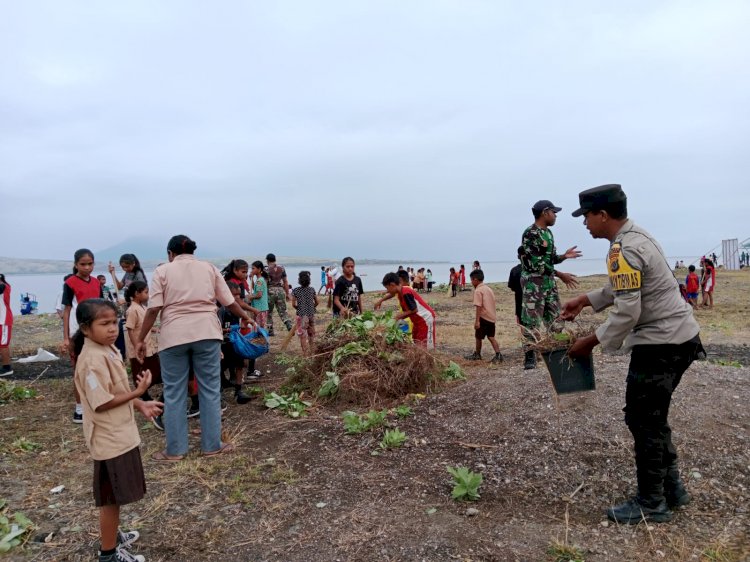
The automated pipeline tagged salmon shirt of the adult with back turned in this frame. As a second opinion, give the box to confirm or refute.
[148,254,234,351]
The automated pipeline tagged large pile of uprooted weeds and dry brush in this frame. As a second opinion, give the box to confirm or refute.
[286,311,441,408]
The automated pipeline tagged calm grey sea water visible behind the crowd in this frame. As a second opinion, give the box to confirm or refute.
[6,258,688,314]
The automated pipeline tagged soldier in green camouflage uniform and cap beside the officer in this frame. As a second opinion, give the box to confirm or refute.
[521,199,581,369]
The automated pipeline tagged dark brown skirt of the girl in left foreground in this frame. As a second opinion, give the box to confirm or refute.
[94,447,146,507]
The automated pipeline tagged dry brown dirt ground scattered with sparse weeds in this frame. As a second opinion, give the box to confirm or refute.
[0,272,750,561]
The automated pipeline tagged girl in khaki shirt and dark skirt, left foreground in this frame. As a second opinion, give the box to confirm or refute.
[74,299,164,562]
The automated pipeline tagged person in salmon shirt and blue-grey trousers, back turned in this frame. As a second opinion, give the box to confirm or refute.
[136,234,253,461]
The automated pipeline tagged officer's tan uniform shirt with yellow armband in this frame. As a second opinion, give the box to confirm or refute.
[587,220,700,350]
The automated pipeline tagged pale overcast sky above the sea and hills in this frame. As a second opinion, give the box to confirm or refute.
[0,0,750,261]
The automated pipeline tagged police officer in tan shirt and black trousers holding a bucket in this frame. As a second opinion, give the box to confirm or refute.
[561,184,705,523]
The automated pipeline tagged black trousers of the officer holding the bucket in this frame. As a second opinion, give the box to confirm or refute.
[623,336,703,505]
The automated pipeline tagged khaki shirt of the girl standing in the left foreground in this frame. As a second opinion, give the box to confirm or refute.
[74,338,141,461]
